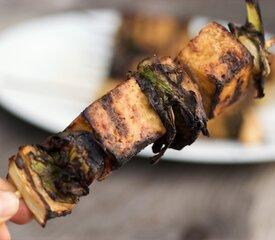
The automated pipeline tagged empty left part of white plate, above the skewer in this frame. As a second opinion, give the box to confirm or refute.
[0,10,121,132]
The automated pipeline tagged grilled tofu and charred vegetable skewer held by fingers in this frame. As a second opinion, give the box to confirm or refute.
[8,0,274,226]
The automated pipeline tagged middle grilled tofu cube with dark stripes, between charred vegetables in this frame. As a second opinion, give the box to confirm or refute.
[66,78,166,164]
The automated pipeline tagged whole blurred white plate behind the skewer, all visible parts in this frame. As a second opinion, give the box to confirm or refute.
[0,13,275,163]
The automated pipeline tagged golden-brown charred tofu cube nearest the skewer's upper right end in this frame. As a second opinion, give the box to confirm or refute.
[176,22,253,118]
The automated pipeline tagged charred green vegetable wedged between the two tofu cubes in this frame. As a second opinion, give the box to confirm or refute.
[135,57,208,163]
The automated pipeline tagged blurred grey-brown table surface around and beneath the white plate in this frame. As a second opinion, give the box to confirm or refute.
[0,0,275,240]
